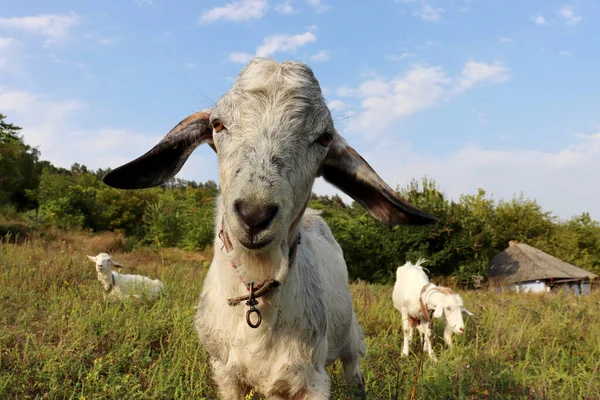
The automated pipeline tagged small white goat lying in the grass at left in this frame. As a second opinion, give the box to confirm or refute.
[88,253,165,300]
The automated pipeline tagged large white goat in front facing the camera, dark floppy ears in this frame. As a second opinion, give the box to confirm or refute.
[104,58,435,400]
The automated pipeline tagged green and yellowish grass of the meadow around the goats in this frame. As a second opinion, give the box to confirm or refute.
[0,233,600,399]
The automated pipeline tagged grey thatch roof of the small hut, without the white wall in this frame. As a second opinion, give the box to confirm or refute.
[489,241,597,283]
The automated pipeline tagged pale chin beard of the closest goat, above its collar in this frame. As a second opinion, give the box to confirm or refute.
[233,242,289,283]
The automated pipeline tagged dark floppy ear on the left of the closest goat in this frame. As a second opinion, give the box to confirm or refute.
[102,110,216,189]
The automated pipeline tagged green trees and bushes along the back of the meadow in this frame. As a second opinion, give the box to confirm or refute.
[0,115,600,287]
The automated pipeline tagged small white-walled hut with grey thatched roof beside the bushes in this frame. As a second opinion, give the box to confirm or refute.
[489,240,598,294]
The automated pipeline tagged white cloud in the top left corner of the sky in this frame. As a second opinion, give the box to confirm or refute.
[0,12,81,45]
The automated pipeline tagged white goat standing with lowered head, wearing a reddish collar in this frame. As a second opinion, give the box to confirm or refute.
[392,259,473,361]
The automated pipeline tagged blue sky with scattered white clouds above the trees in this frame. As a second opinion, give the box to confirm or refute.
[0,0,600,220]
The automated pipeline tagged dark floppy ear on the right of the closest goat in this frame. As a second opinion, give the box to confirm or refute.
[322,133,437,225]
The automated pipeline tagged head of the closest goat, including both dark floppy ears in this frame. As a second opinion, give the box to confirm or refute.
[104,58,435,260]
